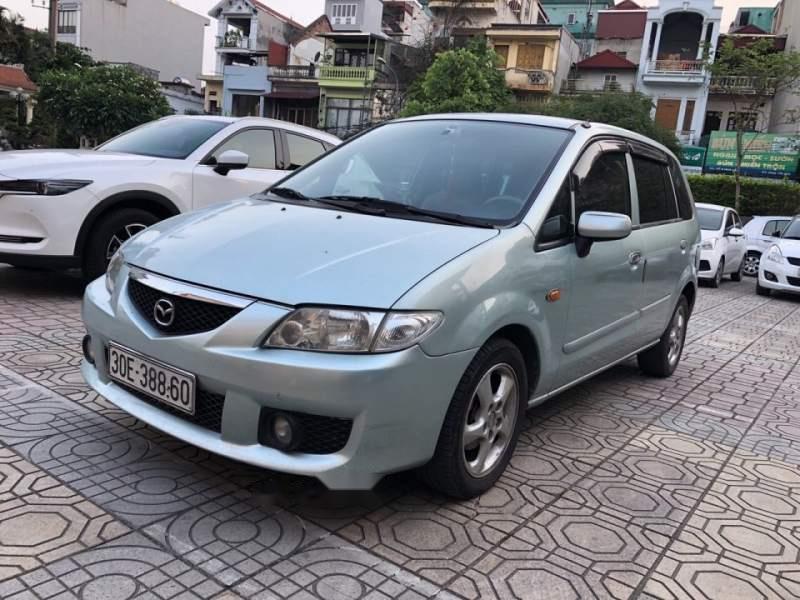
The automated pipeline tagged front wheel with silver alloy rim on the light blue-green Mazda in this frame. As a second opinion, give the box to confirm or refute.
[422,338,528,500]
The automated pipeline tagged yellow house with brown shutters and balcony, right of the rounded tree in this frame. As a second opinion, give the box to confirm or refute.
[486,23,580,100]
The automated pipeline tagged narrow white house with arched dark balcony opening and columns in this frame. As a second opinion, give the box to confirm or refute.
[637,0,722,145]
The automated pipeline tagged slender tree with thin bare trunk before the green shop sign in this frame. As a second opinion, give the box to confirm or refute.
[706,38,800,211]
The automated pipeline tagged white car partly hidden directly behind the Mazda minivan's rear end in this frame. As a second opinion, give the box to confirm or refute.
[697,203,747,287]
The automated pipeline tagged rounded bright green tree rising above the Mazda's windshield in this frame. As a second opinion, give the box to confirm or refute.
[402,38,511,116]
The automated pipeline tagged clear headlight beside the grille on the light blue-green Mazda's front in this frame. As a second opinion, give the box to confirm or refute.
[264,308,442,353]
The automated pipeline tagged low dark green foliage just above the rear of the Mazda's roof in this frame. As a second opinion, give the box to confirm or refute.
[504,92,681,156]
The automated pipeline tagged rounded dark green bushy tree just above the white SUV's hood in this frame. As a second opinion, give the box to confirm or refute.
[38,65,172,146]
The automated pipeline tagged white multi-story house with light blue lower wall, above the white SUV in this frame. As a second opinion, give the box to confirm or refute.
[206,0,305,117]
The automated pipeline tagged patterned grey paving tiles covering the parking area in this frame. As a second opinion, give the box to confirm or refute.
[0,267,800,600]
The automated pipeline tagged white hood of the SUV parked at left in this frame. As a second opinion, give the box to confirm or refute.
[0,150,158,179]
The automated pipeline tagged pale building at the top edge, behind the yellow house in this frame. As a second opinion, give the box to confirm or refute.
[428,0,548,46]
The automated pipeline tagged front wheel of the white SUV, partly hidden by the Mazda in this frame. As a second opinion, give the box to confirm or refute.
[83,208,160,281]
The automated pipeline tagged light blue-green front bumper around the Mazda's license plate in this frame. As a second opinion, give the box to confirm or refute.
[81,277,477,489]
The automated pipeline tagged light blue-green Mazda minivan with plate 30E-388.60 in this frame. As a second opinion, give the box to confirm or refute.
[82,114,700,498]
